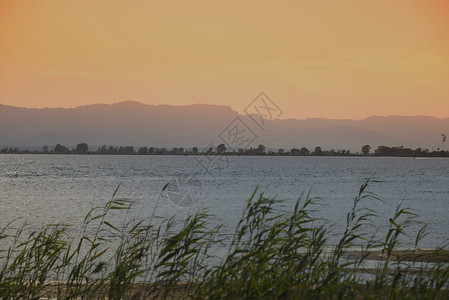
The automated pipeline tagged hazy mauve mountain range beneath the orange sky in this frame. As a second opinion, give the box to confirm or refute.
[0,101,449,151]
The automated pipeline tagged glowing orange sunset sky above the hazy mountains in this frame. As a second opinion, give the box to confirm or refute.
[0,0,449,119]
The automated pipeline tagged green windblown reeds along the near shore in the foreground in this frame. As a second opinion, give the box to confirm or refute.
[0,180,449,299]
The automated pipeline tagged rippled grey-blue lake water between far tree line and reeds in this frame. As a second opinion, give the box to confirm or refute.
[0,155,449,247]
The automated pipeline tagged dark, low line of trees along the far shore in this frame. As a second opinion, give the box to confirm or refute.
[0,143,449,157]
